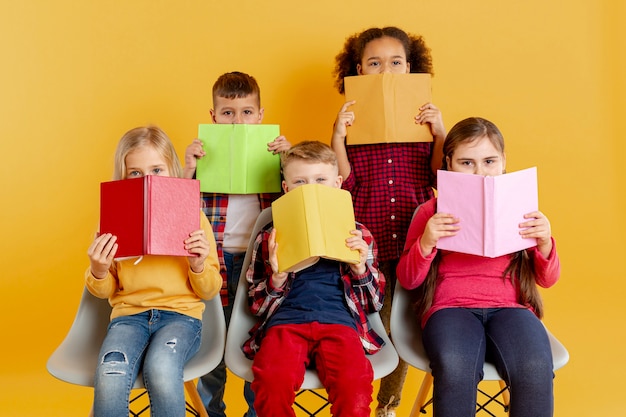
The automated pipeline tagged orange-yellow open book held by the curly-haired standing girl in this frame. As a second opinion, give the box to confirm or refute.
[344,73,433,145]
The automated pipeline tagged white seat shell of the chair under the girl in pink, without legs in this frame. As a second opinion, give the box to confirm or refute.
[390,284,569,381]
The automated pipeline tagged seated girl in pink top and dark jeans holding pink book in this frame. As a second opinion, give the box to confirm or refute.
[398,118,560,417]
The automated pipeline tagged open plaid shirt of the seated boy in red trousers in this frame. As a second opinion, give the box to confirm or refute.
[242,223,385,359]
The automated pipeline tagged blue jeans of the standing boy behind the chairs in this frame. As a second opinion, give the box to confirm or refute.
[198,252,256,417]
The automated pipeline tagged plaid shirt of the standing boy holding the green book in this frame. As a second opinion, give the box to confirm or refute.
[201,193,280,306]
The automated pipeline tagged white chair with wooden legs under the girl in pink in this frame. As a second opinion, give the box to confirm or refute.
[390,285,569,417]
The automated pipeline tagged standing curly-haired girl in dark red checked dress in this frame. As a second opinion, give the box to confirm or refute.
[331,27,446,417]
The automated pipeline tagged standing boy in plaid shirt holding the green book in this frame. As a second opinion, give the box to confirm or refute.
[184,72,291,417]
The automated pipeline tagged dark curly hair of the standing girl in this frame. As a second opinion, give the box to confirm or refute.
[333,26,434,94]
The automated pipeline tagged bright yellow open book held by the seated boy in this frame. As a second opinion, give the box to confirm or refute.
[272,184,360,272]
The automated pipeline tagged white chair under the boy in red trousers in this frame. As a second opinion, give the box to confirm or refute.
[224,208,398,416]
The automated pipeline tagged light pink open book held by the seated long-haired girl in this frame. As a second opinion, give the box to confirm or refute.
[437,167,539,258]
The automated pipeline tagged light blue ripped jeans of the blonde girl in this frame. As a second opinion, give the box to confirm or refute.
[94,310,202,417]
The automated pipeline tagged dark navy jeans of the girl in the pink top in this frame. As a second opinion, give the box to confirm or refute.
[423,308,554,417]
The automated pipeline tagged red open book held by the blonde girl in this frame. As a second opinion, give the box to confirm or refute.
[100,175,200,258]
